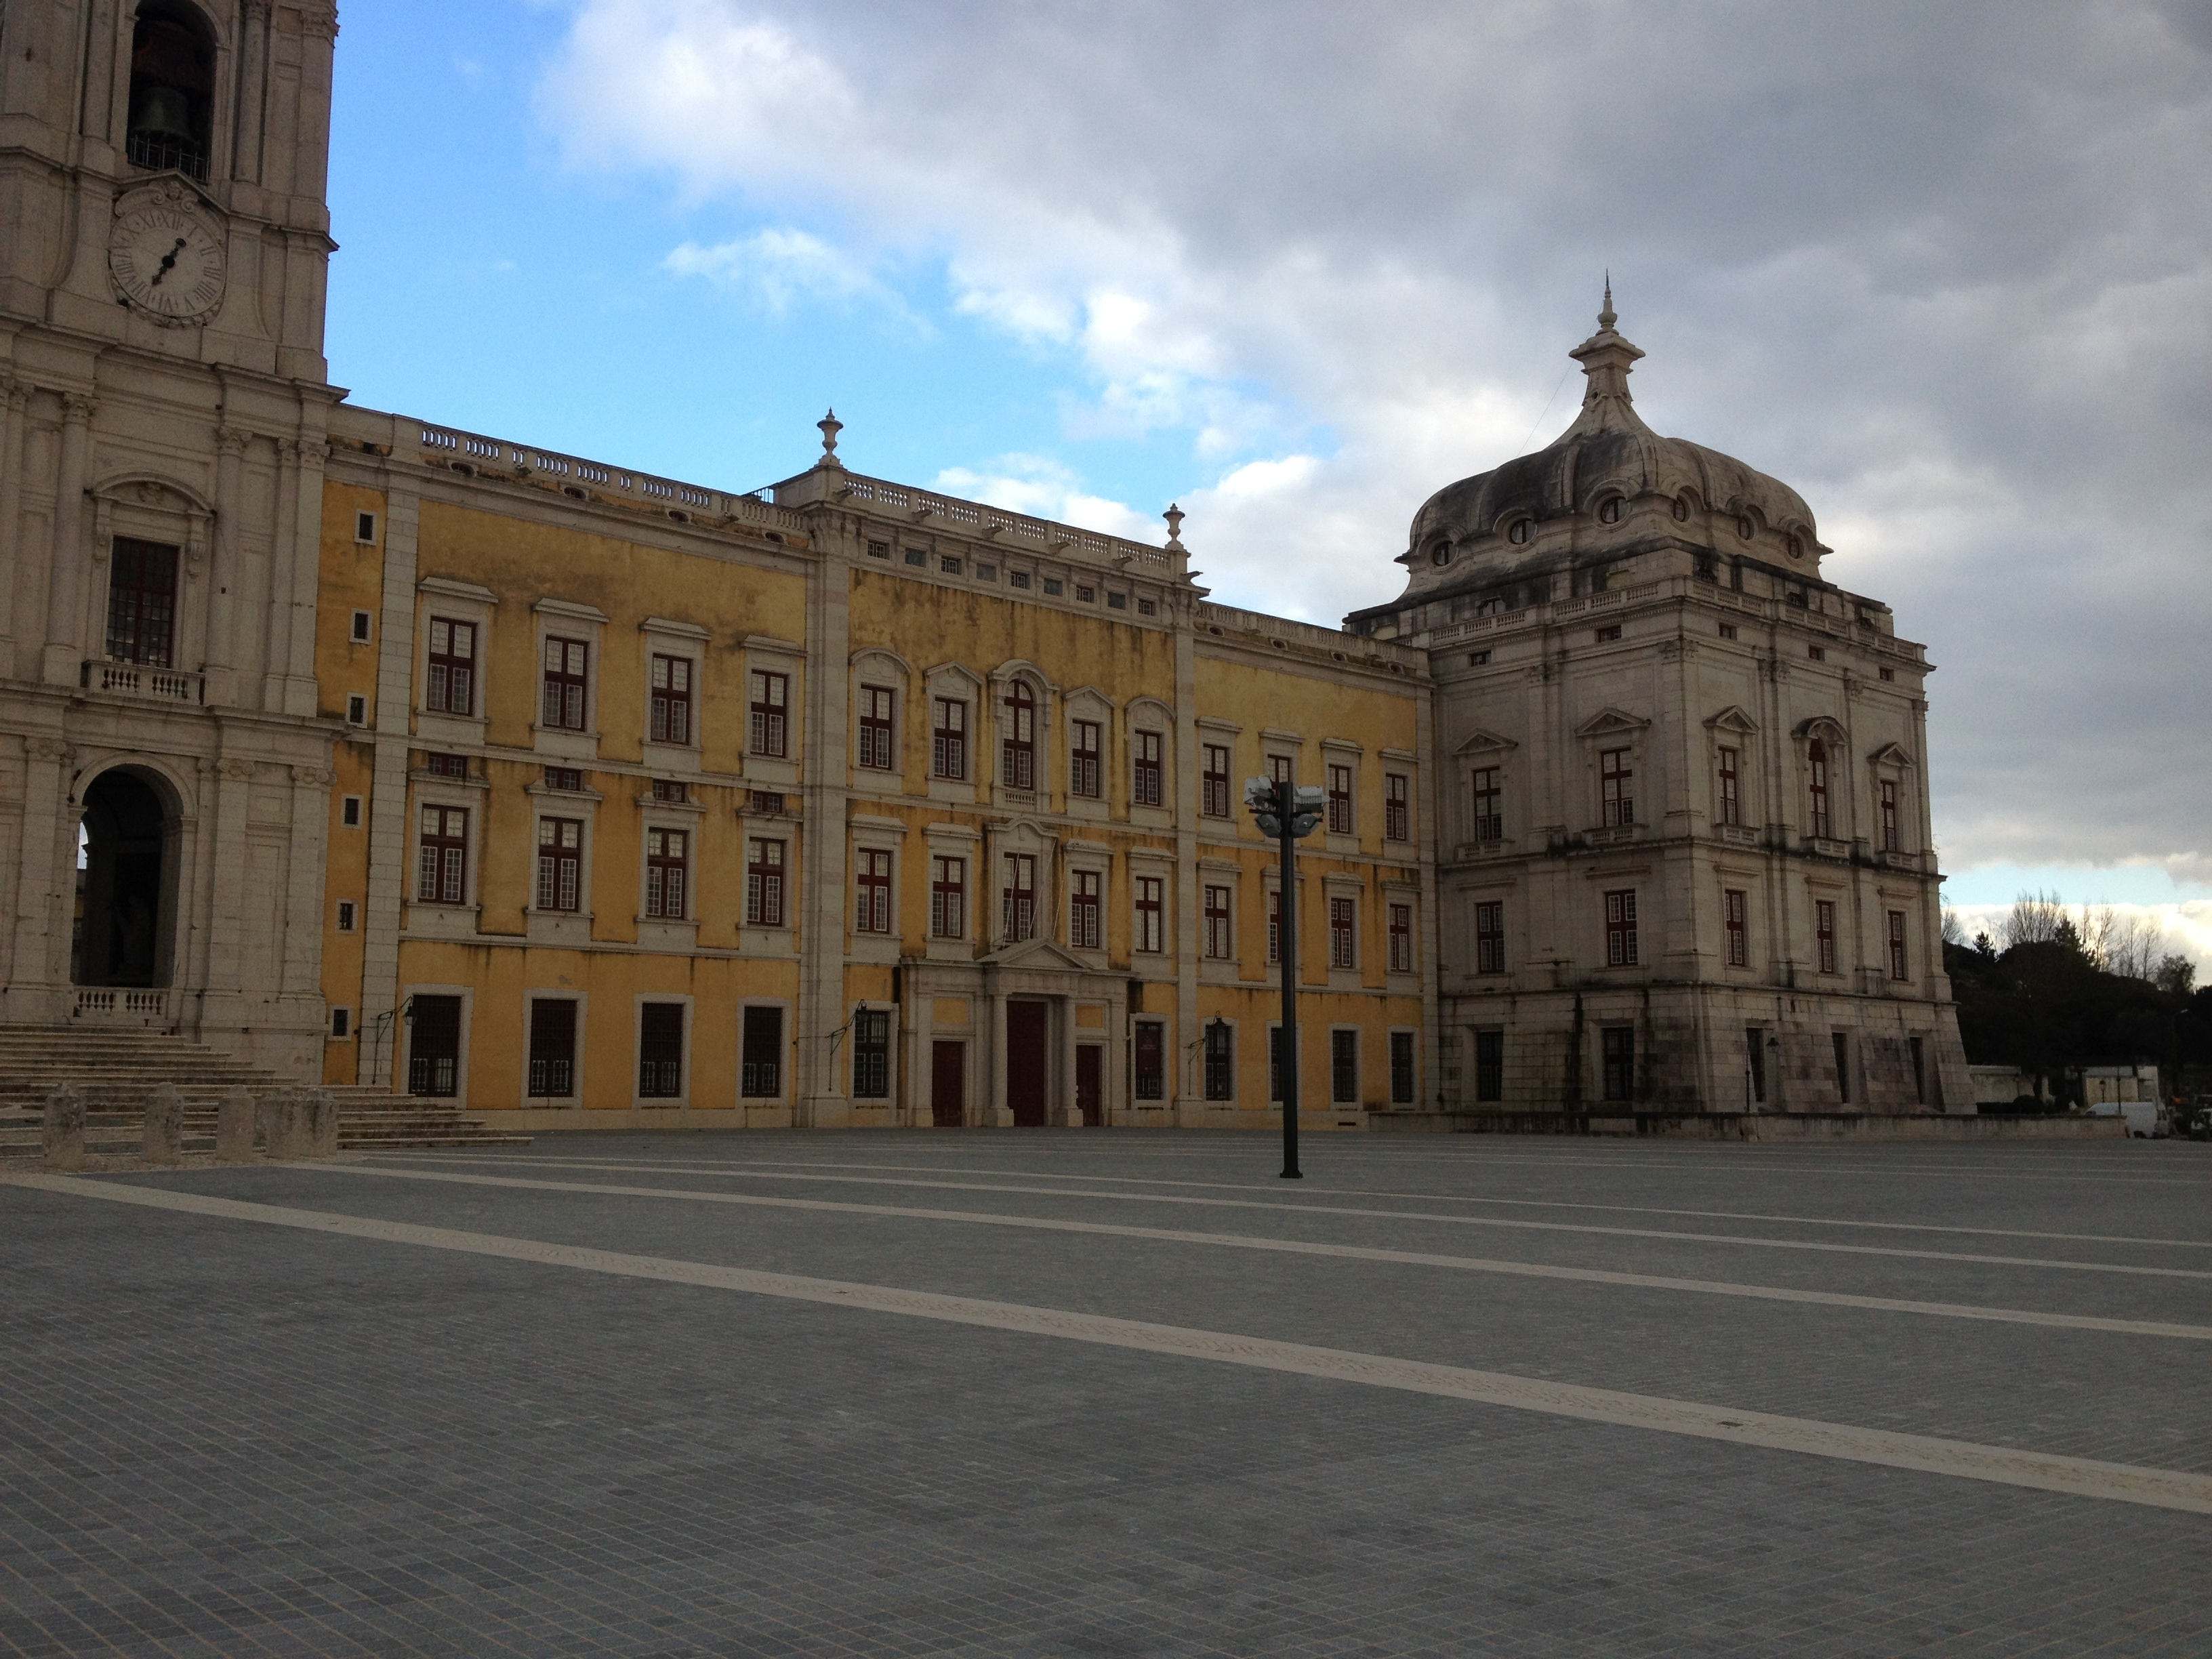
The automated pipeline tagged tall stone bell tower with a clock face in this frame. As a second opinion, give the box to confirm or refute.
[0,0,341,1075]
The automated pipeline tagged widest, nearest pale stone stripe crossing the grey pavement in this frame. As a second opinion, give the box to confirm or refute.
[0,1166,2212,1515]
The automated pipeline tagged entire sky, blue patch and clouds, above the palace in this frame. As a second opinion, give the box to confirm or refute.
[329,0,2212,964]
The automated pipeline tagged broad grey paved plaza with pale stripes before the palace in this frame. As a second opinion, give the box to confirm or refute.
[0,1130,2212,1659]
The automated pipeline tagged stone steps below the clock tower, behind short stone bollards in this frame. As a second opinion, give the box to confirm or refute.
[0,1026,529,1159]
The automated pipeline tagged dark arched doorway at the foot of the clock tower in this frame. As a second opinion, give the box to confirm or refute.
[70,768,175,984]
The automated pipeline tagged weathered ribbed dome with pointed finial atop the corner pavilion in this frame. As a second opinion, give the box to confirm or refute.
[1405,285,1827,590]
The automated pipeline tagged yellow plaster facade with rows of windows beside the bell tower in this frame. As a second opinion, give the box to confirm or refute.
[316,409,1433,1128]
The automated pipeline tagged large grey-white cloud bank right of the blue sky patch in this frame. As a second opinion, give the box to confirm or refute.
[546,0,2212,872]
